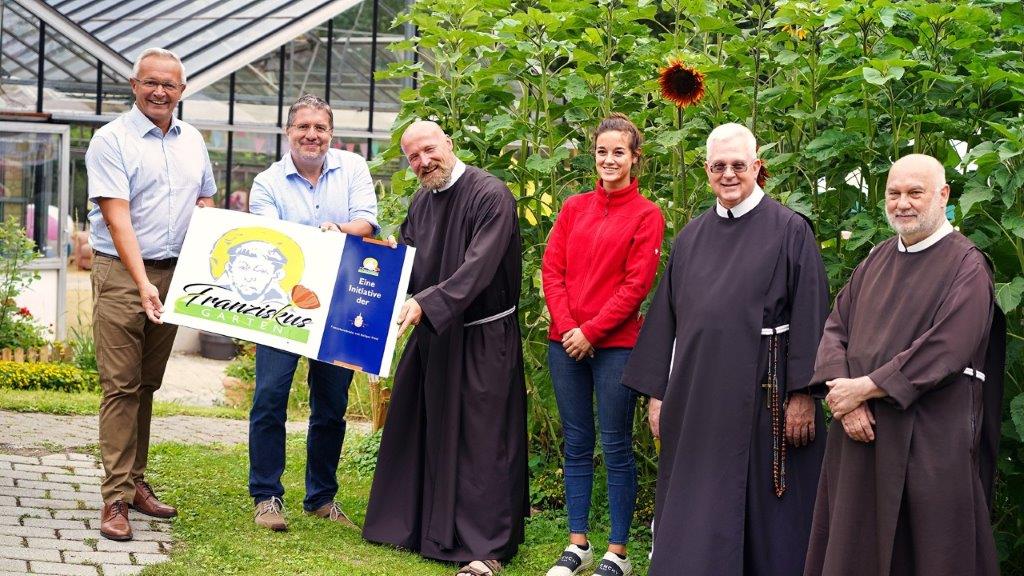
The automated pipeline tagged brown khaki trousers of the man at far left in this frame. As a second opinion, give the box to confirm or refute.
[92,254,177,504]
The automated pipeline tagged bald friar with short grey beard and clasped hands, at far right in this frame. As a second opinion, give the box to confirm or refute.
[804,155,1005,576]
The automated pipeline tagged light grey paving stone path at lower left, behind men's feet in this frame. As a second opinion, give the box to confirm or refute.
[0,411,369,576]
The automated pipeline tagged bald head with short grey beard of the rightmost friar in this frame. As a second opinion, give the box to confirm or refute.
[886,154,949,246]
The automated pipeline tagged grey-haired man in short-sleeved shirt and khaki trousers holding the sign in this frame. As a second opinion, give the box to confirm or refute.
[85,48,216,540]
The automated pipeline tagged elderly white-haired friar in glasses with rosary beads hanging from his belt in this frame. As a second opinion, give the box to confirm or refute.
[623,124,828,576]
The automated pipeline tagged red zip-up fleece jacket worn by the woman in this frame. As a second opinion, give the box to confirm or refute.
[542,179,665,347]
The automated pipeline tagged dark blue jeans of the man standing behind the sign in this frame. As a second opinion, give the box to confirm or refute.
[249,345,352,510]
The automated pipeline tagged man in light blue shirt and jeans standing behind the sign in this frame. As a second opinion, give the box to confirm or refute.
[249,94,378,531]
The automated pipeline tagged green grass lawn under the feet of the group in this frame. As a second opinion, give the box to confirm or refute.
[144,435,648,576]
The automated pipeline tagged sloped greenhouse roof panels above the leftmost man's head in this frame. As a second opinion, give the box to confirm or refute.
[14,0,359,95]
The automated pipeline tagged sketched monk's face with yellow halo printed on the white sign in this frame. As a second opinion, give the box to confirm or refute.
[210,227,315,307]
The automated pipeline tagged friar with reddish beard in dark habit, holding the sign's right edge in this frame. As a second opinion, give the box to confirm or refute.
[362,121,529,576]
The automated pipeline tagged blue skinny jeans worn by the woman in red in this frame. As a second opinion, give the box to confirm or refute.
[548,342,637,544]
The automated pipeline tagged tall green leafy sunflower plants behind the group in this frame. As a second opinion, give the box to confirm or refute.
[378,0,1024,574]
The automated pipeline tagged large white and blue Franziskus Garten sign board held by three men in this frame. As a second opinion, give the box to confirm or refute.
[162,208,415,376]
